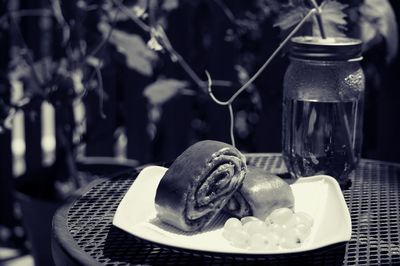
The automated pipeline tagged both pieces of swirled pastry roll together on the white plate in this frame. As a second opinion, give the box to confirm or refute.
[155,140,294,232]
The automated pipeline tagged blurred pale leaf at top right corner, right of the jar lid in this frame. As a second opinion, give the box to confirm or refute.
[360,0,399,62]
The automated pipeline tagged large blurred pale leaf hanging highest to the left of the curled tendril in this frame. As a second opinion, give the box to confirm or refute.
[99,23,157,76]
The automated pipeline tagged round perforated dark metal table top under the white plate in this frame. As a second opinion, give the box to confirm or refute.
[52,154,400,265]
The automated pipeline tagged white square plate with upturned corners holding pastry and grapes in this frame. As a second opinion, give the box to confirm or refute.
[113,166,351,254]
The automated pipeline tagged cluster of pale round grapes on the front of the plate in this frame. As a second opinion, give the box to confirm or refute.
[222,208,313,250]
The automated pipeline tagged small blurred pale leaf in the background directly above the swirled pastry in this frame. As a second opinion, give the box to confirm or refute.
[143,79,193,105]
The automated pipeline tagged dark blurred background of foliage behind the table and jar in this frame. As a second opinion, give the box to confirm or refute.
[0,0,400,174]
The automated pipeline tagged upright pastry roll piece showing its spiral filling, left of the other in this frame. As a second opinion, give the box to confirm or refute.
[155,140,247,231]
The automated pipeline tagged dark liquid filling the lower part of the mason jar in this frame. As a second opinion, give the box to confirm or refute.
[283,99,361,183]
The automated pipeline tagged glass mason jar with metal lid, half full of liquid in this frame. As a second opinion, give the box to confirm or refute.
[282,36,365,186]
